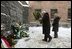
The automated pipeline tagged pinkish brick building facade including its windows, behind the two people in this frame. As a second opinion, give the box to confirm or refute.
[28,1,71,23]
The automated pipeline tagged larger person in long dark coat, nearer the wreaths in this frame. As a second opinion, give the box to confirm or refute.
[42,13,52,42]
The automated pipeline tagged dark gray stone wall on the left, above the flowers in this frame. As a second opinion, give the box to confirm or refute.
[1,1,28,30]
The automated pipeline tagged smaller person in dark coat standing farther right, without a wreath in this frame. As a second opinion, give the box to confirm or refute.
[52,16,60,38]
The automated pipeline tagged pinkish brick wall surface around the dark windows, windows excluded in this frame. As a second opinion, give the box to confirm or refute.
[29,1,71,22]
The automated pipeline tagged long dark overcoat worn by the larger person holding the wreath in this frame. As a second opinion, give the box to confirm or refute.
[42,13,50,34]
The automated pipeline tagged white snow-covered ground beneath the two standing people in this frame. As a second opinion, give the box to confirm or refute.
[15,27,71,48]
